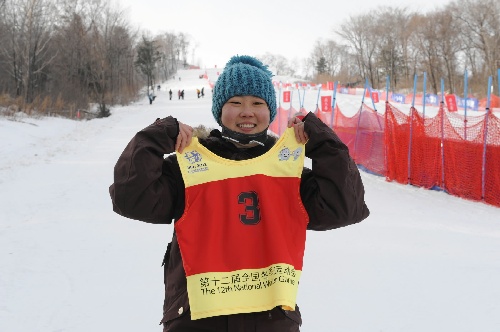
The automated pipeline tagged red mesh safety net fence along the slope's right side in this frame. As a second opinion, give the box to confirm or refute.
[270,103,500,207]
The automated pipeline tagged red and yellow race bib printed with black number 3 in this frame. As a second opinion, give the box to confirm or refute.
[175,128,309,319]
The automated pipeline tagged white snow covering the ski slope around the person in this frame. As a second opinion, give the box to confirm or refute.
[0,70,500,332]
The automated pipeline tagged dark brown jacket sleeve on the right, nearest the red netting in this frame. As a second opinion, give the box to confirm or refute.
[300,113,370,231]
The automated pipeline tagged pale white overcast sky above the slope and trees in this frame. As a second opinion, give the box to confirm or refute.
[116,0,450,68]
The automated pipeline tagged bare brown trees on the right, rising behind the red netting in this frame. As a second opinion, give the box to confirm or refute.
[307,0,500,97]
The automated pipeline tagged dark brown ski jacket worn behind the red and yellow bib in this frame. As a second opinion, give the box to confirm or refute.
[109,113,370,331]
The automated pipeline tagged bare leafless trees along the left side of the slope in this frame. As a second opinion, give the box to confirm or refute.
[0,0,189,117]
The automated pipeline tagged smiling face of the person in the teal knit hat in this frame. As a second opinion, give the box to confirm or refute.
[221,96,271,134]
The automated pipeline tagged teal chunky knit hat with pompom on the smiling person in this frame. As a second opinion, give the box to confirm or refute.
[212,55,276,125]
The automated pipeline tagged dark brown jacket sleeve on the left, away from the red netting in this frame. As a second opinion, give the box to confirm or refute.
[109,117,183,224]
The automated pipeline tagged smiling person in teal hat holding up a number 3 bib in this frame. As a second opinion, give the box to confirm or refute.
[109,56,369,332]
